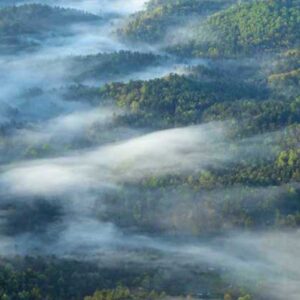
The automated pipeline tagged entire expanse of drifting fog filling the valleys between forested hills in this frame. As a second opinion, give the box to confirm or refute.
[0,0,300,300]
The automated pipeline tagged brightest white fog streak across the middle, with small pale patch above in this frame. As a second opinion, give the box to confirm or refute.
[1,122,288,195]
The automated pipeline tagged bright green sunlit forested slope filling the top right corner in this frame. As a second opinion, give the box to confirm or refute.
[171,0,300,56]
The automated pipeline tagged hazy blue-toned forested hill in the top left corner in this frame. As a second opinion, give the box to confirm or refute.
[0,4,100,52]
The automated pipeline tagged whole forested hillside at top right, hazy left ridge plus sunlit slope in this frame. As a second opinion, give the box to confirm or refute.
[120,0,300,57]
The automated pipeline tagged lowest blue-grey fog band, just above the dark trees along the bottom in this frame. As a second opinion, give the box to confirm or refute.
[1,217,300,300]
